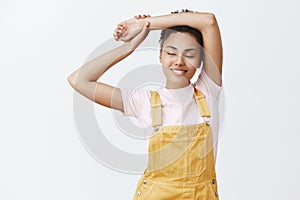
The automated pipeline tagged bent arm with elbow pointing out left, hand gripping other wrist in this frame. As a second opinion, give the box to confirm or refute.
[68,21,149,112]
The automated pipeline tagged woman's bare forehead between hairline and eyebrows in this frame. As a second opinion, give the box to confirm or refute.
[163,32,200,50]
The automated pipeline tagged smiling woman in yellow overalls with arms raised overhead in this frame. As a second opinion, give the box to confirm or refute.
[68,10,222,200]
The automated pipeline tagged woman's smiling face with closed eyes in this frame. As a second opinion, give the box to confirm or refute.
[159,32,201,88]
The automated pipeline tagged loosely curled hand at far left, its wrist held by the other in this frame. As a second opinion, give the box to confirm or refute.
[113,15,150,42]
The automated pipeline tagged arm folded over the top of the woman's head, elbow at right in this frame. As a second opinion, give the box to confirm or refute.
[115,12,223,85]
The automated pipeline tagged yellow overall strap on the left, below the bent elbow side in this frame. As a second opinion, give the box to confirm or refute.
[150,91,162,127]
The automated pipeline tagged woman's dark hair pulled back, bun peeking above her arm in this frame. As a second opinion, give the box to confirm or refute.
[159,9,204,63]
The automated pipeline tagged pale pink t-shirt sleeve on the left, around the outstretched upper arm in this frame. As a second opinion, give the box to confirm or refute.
[120,88,150,118]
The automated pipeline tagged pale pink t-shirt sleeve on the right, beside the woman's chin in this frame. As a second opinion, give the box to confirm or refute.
[195,69,223,99]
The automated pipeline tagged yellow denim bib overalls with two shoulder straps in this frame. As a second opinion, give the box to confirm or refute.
[134,89,219,200]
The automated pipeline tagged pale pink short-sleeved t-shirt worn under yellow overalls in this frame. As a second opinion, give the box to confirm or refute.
[121,70,222,163]
